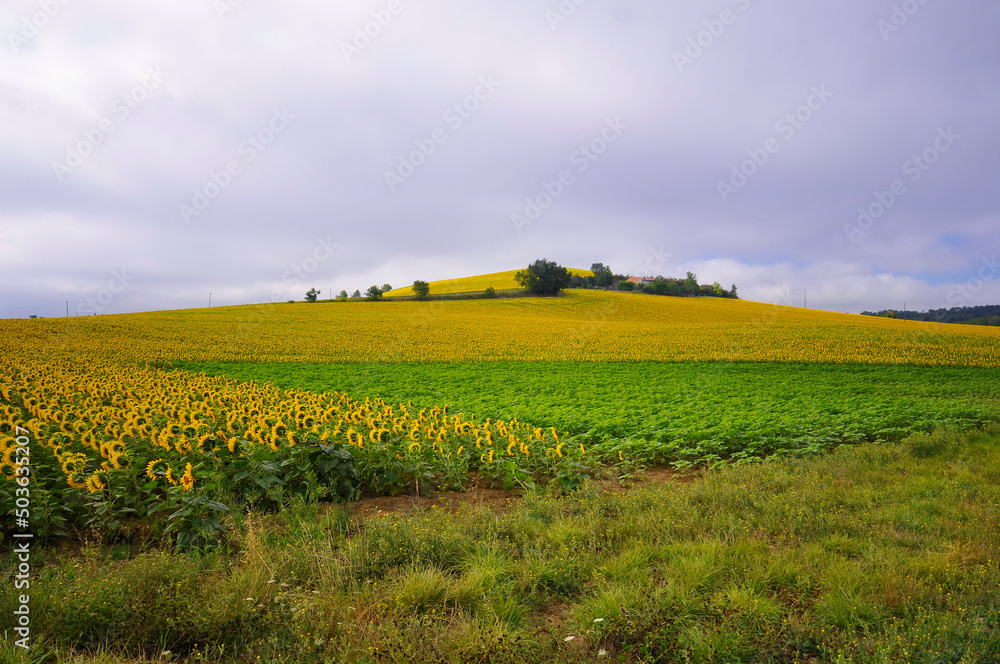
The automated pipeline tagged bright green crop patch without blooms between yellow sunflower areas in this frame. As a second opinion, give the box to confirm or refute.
[184,362,1000,468]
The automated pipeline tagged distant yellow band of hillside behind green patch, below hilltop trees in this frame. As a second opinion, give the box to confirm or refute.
[0,290,1000,367]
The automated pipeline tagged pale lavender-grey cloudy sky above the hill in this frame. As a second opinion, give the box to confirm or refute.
[0,0,1000,317]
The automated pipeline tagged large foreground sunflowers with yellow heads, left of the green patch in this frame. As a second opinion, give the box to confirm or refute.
[0,358,586,544]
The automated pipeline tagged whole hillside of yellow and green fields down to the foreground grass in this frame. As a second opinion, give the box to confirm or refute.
[7,274,1000,664]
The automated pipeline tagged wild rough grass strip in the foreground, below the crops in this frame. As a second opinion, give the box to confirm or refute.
[0,427,1000,664]
